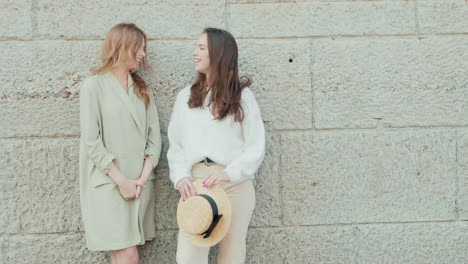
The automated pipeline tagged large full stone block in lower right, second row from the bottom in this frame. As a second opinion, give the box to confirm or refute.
[280,129,457,225]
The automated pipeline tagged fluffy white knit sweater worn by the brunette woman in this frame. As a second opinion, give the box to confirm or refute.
[167,86,265,187]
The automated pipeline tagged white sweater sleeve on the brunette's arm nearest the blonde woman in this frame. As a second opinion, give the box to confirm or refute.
[167,91,192,188]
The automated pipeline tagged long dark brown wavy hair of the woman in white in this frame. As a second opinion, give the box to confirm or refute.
[188,28,252,122]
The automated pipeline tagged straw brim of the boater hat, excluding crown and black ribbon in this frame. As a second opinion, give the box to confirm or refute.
[177,180,232,248]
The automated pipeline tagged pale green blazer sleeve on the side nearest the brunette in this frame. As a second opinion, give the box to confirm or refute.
[145,92,161,168]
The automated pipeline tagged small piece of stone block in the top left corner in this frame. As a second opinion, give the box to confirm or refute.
[0,0,33,40]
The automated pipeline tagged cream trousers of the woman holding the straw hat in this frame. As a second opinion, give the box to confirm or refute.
[176,163,255,264]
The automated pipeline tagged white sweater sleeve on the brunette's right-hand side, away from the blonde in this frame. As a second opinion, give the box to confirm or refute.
[224,88,265,184]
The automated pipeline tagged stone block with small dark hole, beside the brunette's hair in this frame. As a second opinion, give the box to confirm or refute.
[239,39,312,129]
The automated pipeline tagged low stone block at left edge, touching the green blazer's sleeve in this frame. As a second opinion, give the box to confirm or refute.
[0,98,80,137]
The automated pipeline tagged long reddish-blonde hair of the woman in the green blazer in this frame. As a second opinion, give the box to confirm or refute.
[91,23,150,109]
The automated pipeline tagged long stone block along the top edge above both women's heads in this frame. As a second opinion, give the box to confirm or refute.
[37,0,224,39]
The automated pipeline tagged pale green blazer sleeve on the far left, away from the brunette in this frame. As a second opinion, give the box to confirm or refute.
[80,78,115,174]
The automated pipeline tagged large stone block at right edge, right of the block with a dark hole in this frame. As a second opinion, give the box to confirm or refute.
[312,37,468,128]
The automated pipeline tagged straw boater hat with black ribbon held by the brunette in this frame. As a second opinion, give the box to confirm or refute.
[177,180,231,247]
